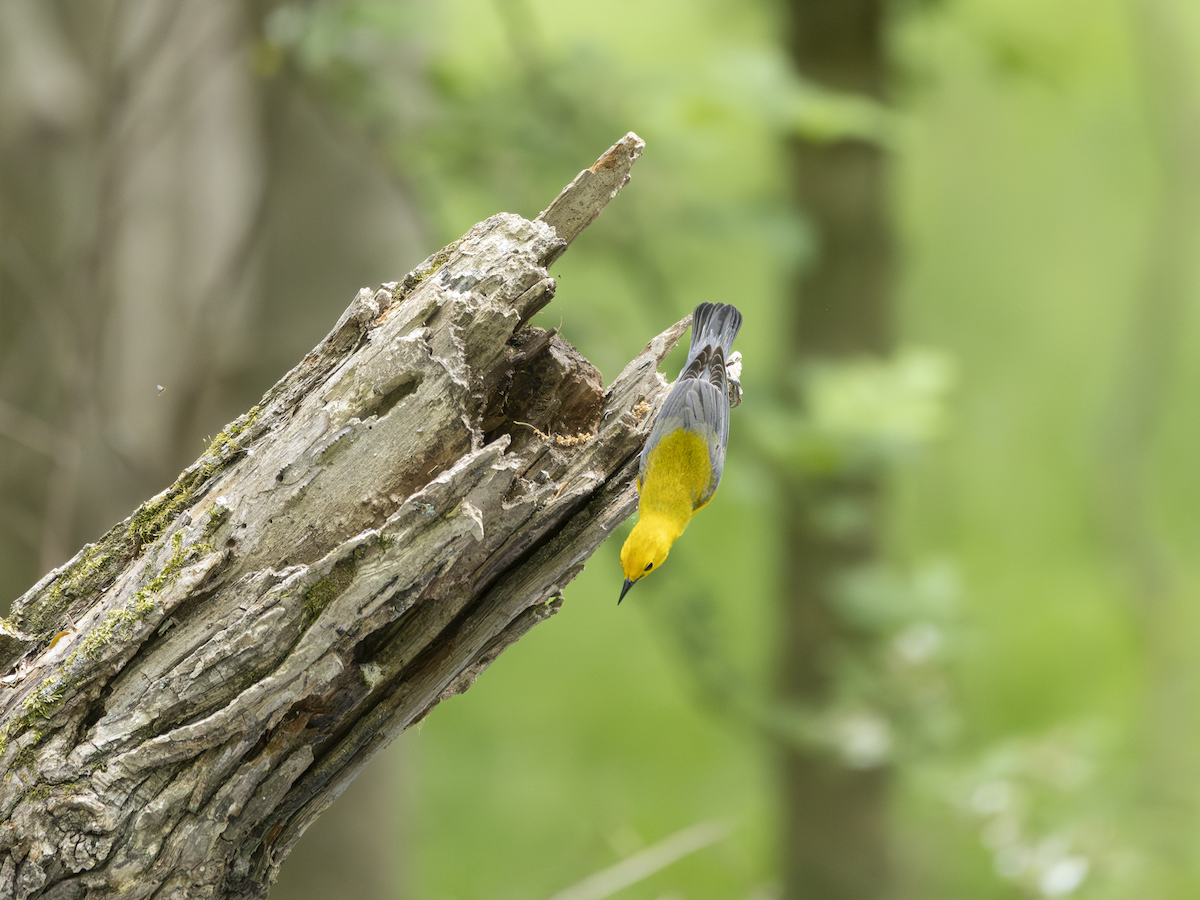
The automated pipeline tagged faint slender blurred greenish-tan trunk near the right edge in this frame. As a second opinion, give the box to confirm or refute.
[1097,0,1200,884]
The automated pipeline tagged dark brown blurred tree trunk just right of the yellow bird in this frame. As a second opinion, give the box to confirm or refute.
[780,0,892,900]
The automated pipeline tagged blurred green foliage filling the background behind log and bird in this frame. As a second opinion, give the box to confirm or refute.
[258,0,1200,899]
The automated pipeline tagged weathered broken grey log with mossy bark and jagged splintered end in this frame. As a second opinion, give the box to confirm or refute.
[0,134,686,899]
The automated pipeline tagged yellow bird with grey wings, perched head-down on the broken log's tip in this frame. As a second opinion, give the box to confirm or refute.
[617,304,742,604]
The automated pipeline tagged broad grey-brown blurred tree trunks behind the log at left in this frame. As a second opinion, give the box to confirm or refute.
[0,0,424,898]
